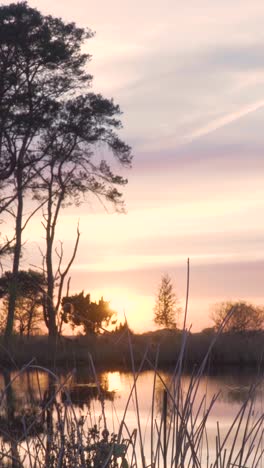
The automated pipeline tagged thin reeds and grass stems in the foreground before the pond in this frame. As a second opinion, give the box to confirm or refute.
[0,324,264,468]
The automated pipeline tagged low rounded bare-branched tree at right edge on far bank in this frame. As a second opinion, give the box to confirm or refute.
[211,301,264,333]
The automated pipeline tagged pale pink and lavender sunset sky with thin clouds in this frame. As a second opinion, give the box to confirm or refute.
[2,0,264,332]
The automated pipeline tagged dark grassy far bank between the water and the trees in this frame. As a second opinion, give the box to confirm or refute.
[0,330,264,369]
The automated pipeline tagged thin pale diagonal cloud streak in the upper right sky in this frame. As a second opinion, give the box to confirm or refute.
[184,99,264,143]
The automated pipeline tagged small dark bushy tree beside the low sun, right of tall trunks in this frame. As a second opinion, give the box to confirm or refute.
[62,291,116,335]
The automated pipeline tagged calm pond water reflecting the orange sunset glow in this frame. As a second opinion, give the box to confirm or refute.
[0,366,264,468]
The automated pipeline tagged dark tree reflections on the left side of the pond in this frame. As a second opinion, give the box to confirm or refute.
[0,369,115,468]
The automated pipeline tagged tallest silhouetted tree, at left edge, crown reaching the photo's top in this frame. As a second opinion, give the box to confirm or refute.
[0,2,91,339]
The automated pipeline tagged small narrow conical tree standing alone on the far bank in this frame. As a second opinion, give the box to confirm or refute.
[154,275,181,328]
